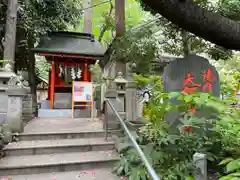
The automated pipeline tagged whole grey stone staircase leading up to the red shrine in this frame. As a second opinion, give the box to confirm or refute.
[0,119,120,180]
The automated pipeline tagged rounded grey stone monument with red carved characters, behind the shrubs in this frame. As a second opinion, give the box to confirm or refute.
[163,55,220,132]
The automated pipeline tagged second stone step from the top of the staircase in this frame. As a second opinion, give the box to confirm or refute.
[4,138,114,156]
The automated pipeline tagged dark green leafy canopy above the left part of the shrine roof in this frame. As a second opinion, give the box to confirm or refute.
[19,0,82,35]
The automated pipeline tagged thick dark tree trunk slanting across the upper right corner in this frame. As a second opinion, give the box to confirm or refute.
[141,0,240,50]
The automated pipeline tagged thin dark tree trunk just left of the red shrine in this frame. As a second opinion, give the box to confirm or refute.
[27,32,37,116]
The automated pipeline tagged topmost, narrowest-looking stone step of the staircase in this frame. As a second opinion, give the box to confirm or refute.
[18,130,122,141]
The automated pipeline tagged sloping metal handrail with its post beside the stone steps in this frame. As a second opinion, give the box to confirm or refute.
[104,99,160,180]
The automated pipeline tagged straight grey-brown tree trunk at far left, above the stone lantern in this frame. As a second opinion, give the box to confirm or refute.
[3,0,18,70]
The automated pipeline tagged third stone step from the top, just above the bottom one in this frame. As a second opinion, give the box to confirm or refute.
[0,150,119,176]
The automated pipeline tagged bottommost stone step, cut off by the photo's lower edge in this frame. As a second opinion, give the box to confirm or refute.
[0,168,122,180]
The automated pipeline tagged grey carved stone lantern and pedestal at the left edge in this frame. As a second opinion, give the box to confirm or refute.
[0,64,32,132]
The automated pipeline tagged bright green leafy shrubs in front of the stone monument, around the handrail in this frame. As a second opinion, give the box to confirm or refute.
[115,92,240,180]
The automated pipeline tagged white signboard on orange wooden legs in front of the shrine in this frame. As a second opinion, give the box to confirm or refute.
[72,81,94,120]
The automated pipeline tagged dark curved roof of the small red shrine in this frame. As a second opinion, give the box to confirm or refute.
[32,32,105,57]
